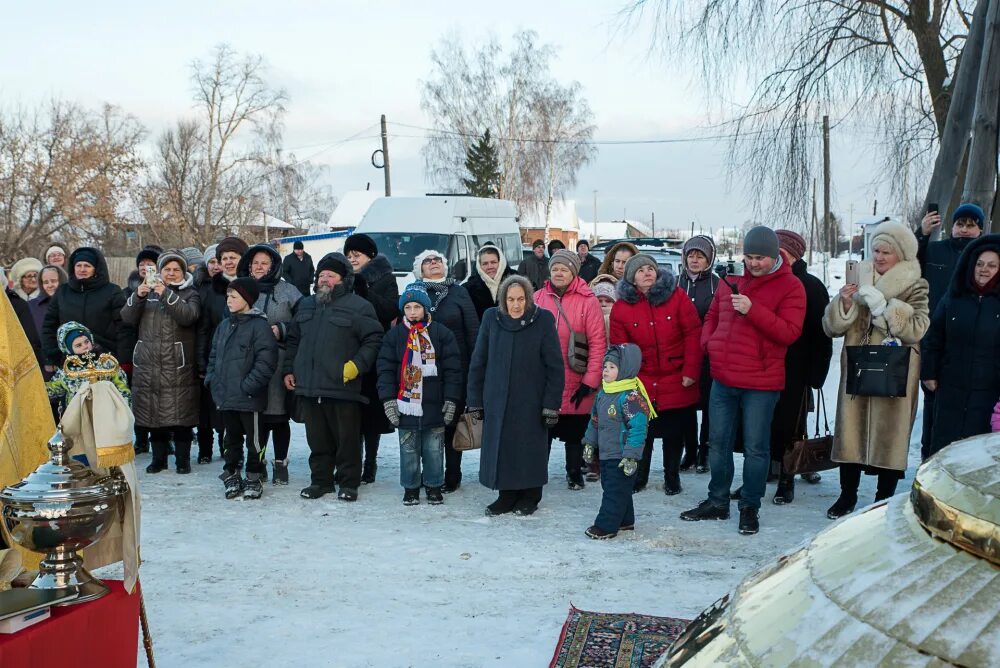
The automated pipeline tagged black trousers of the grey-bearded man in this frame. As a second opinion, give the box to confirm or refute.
[299,397,361,489]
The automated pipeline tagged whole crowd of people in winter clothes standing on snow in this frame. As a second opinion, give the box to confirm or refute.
[4,204,1000,539]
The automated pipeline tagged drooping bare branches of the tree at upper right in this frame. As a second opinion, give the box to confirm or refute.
[621,0,969,213]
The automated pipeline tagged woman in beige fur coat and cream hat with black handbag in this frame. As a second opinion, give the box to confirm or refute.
[823,222,930,519]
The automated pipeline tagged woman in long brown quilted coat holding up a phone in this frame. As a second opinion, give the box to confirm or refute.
[121,251,201,473]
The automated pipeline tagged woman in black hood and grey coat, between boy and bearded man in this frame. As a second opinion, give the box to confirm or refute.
[236,244,302,485]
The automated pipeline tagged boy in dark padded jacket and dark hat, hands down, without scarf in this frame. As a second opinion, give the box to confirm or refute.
[205,277,278,499]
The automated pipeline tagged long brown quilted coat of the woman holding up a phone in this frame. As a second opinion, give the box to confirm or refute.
[122,274,201,429]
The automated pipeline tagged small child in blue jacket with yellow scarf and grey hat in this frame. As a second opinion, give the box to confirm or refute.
[583,343,656,540]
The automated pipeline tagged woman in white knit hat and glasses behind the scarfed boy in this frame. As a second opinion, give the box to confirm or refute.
[413,250,479,494]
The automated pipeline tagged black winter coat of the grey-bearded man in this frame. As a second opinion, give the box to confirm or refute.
[281,268,382,404]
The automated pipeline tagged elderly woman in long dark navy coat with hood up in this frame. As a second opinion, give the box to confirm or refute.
[468,276,565,515]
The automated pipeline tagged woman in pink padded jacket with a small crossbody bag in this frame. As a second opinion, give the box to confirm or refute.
[535,249,608,489]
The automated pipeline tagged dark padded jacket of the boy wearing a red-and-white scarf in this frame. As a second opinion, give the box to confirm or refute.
[378,322,464,429]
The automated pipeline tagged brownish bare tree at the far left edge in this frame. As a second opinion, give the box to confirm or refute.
[0,101,144,261]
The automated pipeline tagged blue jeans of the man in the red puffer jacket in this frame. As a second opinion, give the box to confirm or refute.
[708,381,781,509]
